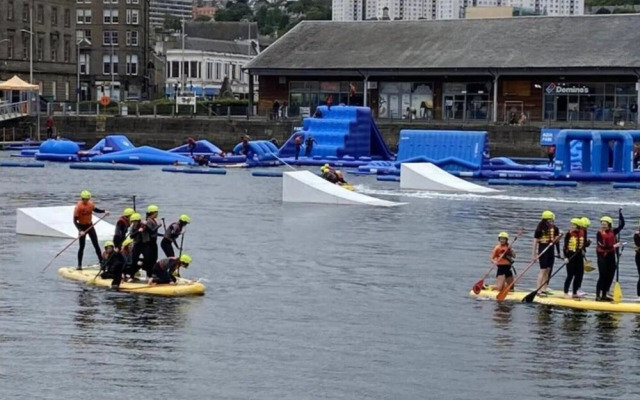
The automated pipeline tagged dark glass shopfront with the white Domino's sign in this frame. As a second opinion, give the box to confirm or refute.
[543,82,637,122]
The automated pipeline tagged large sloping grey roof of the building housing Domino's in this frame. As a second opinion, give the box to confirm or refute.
[246,14,640,74]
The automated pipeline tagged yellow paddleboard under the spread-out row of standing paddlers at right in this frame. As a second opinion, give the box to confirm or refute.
[469,289,640,314]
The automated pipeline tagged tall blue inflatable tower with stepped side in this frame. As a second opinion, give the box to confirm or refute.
[278,106,395,160]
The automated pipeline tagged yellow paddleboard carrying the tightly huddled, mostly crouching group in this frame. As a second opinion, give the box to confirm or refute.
[58,267,205,297]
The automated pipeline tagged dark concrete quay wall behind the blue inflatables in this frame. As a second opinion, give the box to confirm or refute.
[28,116,616,157]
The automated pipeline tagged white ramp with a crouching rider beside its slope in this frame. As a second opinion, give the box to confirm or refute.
[282,171,405,207]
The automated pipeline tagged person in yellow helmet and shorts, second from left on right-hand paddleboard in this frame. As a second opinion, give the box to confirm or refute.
[531,210,560,296]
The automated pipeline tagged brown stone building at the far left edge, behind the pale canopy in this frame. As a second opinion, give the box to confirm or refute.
[0,0,77,101]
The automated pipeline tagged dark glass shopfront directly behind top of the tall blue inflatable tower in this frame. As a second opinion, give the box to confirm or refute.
[288,81,364,116]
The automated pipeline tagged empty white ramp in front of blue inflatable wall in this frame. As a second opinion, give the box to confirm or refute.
[400,163,498,193]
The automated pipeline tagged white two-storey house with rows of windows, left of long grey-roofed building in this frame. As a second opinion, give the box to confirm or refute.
[165,37,259,98]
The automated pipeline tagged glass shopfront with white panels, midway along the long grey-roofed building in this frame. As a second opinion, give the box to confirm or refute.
[378,82,433,119]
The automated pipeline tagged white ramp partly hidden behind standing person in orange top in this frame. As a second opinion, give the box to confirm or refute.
[16,206,116,240]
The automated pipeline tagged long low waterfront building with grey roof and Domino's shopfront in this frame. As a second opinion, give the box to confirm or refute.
[246,14,640,121]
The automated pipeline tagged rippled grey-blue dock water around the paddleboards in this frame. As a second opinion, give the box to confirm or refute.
[0,158,640,400]
